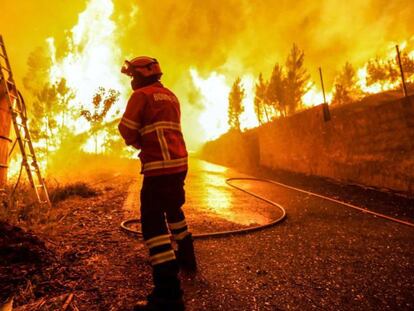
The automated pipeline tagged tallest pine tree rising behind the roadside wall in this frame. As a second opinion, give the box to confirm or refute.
[286,44,310,114]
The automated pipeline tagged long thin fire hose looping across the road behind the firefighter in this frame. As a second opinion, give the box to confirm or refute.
[121,177,414,239]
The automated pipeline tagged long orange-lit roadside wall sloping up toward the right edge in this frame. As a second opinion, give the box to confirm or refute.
[202,96,414,195]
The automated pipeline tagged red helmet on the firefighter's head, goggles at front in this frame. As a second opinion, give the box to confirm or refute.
[121,56,162,78]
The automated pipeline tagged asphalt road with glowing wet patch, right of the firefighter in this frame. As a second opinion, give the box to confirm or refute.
[125,160,414,310]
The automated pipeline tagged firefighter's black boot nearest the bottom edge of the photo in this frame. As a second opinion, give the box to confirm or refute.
[134,261,185,311]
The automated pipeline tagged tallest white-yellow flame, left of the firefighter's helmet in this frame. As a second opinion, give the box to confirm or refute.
[47,0,128,152]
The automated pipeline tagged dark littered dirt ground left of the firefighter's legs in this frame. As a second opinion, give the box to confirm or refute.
[0,157,151,310]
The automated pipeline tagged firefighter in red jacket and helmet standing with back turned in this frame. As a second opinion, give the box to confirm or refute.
[118,56,197,310]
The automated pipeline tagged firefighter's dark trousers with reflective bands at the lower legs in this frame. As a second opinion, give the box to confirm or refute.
[141,172,189,299]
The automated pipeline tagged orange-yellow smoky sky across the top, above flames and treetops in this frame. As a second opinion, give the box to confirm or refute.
[0,0,414,86]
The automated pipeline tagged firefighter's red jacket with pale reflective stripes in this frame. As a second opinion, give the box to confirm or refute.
[118,82,187,176]
